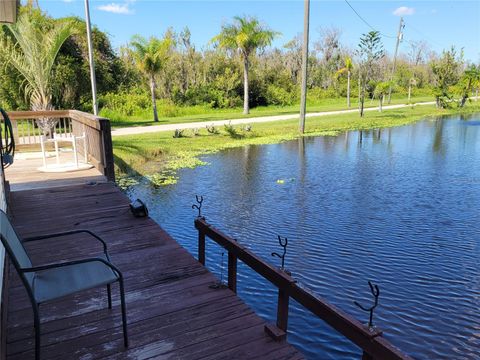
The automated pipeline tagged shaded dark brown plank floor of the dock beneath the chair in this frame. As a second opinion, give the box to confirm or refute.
[3,183,303,360]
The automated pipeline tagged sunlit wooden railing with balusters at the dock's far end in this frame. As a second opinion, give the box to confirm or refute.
[8,110,115,181]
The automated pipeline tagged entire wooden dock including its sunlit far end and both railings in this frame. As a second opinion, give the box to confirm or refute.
[0,110,411,360]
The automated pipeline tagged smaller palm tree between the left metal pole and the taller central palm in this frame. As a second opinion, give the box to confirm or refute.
[130,34,173,122]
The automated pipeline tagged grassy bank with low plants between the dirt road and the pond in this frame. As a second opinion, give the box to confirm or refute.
[113,103,480,185]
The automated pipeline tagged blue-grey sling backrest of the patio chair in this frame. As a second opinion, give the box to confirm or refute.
[0,210,34,286]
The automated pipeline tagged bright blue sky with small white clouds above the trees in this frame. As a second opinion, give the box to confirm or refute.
[39,0,480,63]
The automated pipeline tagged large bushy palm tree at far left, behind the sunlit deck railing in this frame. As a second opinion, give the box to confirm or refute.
[5,7,75,134]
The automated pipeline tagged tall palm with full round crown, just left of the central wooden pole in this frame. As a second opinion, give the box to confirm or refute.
[212,16,279,114]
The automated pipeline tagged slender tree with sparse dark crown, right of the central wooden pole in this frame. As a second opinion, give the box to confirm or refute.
[357,31,385,117]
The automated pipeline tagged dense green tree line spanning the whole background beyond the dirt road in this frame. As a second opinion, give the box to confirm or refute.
[0,7,480,119]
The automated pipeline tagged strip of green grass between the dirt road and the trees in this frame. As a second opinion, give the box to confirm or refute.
[100,96,434,128]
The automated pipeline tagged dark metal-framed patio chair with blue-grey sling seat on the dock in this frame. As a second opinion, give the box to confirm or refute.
[0,210,128,360]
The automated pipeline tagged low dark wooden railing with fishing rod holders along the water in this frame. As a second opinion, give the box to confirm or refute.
[195,218,411,360]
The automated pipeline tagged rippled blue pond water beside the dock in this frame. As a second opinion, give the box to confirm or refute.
[124,114,480,359]
